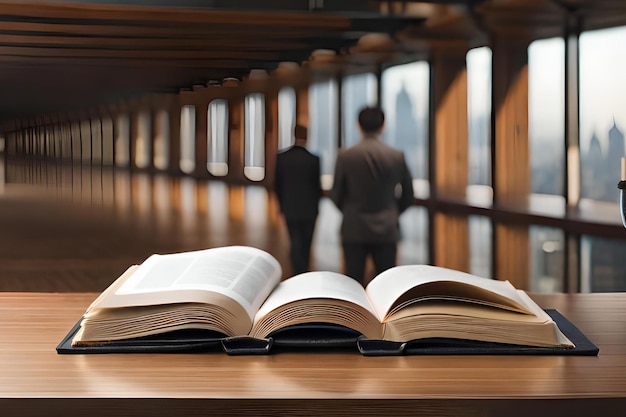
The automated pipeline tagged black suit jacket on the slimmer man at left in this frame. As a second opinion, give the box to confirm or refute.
[274,145,322,219]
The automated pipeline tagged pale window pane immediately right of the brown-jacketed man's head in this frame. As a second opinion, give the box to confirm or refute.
[382,61,430,179]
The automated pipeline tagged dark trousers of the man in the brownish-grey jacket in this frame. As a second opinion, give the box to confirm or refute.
[343,242,397,284]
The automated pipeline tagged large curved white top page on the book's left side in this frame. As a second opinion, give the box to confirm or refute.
[92,246,282,319]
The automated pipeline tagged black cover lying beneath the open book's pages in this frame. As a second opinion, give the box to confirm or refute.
[56,310,599,356]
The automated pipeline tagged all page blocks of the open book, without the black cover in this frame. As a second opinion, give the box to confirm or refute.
[62,246,574,349]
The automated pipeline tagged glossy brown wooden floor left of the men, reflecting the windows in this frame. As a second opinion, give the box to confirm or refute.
[0,158,294,292]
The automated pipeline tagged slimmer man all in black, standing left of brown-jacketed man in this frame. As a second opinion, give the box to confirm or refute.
[274,126,322,275]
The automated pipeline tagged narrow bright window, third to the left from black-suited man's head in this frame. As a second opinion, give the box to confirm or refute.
[207,99,228,177]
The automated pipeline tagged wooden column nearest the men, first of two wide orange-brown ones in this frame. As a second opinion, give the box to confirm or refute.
[430,46,470,272]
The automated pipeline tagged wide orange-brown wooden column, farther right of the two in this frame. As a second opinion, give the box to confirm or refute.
[492,36,530,289]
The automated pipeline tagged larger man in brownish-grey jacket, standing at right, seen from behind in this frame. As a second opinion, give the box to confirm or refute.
[330,108,413,284]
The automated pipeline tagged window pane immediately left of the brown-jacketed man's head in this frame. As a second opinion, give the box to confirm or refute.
[341,74,376,147]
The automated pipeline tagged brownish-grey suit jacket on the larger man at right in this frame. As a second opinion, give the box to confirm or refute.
[330,137,413,243]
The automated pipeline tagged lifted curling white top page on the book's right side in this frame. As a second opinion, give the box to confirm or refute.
[366,265,533,322]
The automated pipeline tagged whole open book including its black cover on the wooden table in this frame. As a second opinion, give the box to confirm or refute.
[57,246,597,355]
